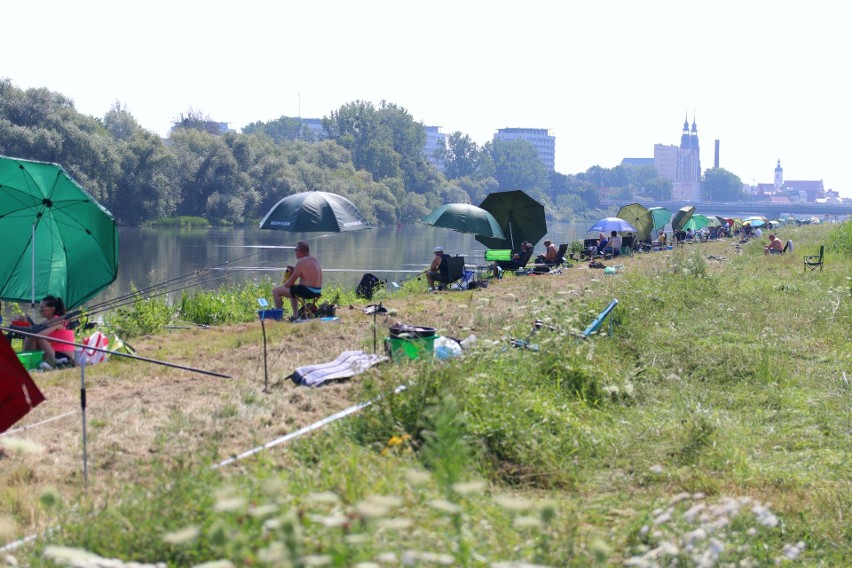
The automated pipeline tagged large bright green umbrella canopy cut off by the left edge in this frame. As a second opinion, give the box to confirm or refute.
[0,156,118,309]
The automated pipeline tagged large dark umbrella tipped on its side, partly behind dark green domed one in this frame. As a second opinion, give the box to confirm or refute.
[476,190,547,250]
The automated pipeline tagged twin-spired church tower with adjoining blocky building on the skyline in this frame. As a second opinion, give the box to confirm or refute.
[654,113,701,201]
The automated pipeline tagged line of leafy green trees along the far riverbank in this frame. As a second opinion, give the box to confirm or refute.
[0,79,744,225]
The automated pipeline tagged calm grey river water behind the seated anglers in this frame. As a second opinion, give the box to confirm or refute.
[105,223,584,304]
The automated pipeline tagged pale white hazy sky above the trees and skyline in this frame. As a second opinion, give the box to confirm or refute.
[0,0,852,197]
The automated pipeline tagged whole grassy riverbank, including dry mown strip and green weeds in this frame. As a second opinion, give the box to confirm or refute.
[0,223,852,566]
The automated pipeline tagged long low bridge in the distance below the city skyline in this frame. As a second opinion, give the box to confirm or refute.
[601,201,852,219]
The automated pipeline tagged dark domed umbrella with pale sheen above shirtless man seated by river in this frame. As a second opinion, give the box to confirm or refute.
[260,191,371,233]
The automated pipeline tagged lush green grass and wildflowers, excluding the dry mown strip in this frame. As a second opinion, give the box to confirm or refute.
[6,223,852,566]
